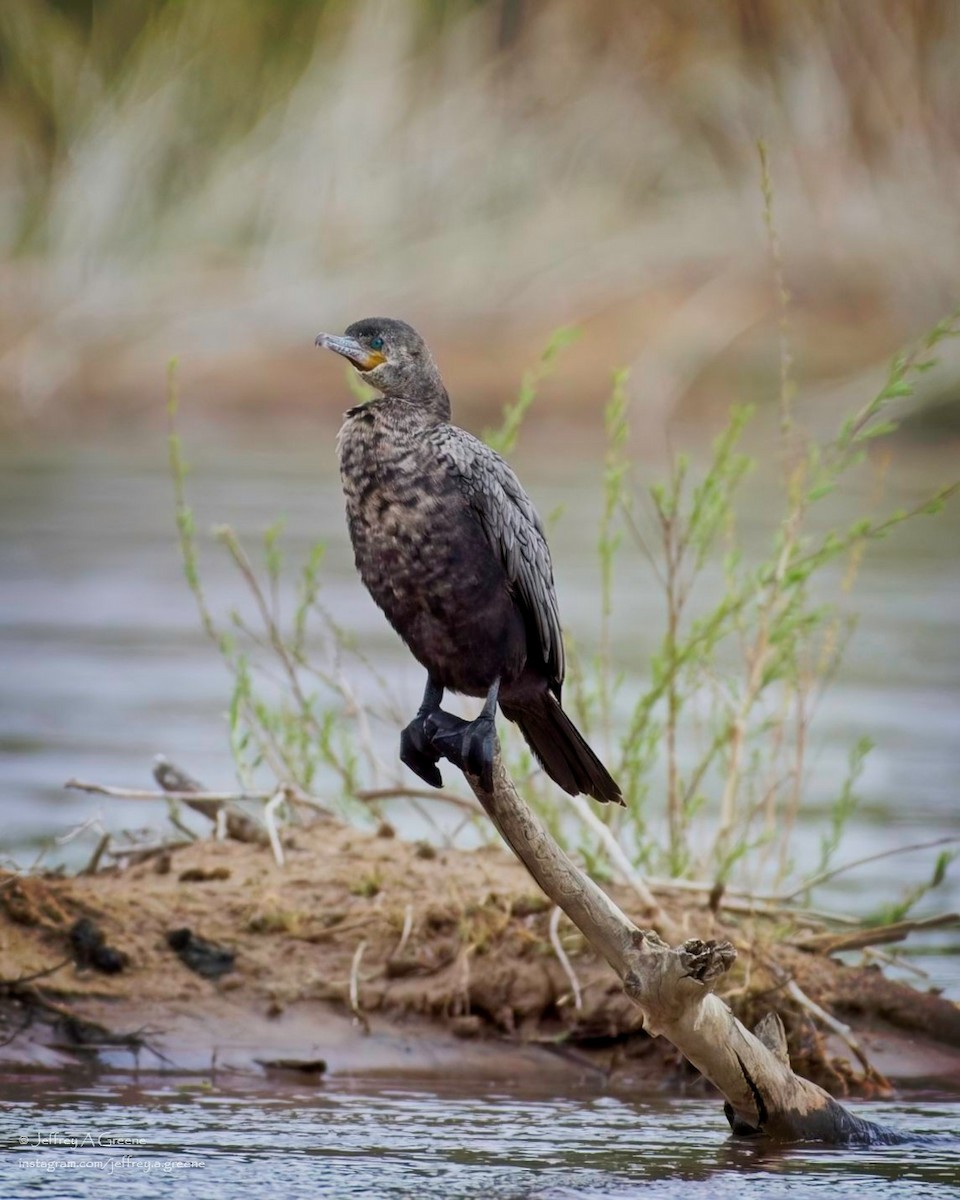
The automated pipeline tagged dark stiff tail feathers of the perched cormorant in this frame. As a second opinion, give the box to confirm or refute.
[500,691,623,804]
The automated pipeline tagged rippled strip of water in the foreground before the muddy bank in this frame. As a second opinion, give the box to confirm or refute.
[0,1080,960,1200]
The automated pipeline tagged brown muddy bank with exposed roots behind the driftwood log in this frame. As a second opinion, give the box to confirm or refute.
[0,821,960,1094]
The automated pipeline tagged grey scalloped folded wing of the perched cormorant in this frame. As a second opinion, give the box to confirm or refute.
[439,425,565,695]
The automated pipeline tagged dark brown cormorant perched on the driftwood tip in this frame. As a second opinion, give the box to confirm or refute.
[317,317,623,804]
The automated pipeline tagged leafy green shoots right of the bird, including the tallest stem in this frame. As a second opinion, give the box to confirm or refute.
[554,148,960,883]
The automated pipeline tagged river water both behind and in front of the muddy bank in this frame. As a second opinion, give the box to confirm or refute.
[0,438,960,1200]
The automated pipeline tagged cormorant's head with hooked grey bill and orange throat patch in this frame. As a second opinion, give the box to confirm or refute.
[317,317,446,402]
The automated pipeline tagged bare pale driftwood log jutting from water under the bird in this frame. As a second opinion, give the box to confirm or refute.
[441,744,904,1145]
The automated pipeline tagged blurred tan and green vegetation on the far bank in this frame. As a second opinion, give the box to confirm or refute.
[0,0,960,454]
